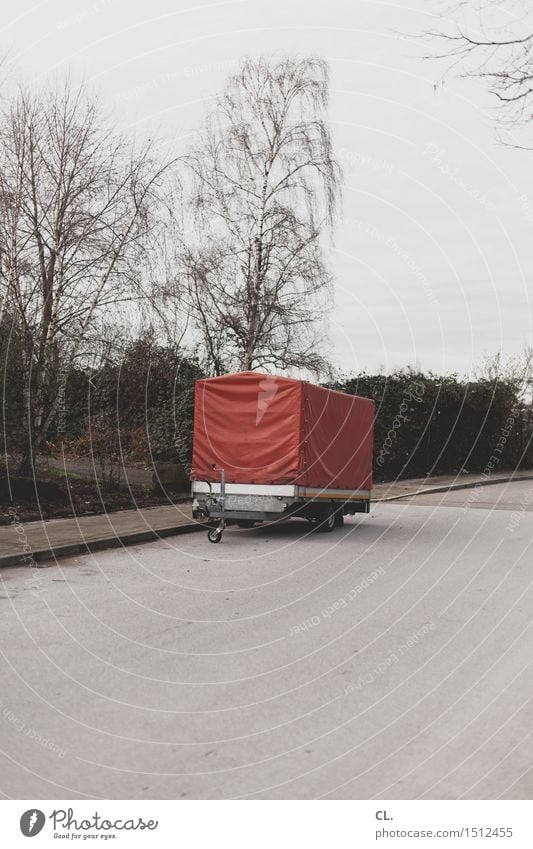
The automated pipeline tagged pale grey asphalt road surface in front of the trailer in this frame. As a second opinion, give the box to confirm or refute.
[0,481,533,799]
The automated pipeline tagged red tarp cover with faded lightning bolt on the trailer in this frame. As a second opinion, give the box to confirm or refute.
[191,372,374,490]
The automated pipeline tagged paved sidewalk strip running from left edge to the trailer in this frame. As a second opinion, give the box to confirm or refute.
[0,503,203,568]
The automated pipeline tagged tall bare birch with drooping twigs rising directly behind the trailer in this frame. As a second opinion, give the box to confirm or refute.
[181,56,340,374]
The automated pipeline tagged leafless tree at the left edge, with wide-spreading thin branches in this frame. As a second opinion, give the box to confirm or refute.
[0,84,176,474]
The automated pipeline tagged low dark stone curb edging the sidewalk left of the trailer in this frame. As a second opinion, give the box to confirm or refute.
[0,522,205,569]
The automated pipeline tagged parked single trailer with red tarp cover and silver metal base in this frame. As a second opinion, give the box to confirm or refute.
[191,372,374,543]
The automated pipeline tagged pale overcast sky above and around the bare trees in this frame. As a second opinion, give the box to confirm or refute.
[0,0,533,373]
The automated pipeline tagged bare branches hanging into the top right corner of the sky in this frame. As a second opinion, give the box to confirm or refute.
[427,0,533,142]
